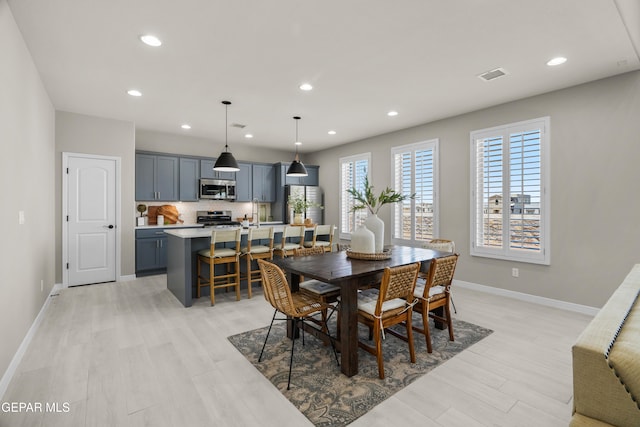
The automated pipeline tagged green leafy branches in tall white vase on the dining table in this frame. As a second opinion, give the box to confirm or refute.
[347,175,416,252]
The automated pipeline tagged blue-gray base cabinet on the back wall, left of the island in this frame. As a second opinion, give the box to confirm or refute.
[136,228,168,276]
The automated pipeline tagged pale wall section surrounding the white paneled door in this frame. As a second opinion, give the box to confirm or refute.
[55,111,136,282]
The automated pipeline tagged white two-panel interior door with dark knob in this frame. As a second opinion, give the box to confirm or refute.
[65,156,117,286]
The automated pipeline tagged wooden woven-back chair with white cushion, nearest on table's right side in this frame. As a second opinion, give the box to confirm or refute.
[338,262,420,379]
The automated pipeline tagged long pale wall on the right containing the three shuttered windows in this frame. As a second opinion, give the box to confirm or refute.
[308,71,640,307]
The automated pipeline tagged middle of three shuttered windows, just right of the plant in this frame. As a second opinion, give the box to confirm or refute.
[391,139,438,246]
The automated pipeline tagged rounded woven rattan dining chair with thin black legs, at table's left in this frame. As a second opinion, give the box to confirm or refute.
[258,259,340,390]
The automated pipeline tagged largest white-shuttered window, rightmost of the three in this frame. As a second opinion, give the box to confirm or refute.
[471,117,550,264]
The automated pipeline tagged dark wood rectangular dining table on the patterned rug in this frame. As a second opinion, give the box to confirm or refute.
[273,246,448,377]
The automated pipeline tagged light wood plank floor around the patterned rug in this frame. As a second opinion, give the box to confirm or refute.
[0,276,590,427]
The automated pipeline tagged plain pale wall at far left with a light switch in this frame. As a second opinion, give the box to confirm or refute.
[0,0,55,388]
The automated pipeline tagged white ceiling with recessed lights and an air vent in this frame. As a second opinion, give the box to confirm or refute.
[8,0,640,152]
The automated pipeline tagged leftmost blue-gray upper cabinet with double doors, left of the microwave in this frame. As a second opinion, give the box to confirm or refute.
[136,153,179,201]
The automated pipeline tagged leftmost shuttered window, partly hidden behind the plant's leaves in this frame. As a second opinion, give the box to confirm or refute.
[340,153,371,240]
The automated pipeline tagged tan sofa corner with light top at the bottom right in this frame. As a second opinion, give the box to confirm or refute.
[569,264,640,427]
